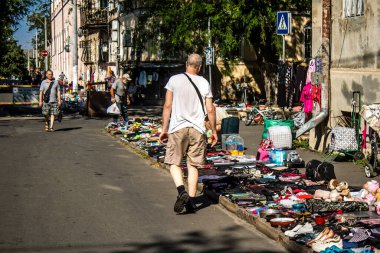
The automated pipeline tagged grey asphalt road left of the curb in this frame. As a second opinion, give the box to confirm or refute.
[0,117,285,253]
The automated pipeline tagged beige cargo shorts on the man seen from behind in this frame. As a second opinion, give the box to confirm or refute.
[164,127,207,167]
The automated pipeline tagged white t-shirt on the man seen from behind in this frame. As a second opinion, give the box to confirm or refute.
[165,73,212,133]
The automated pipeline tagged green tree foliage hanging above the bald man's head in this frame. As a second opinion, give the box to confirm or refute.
[139,0,311,61]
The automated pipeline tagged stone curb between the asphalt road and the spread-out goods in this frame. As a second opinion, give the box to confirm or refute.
[104,131,313,253]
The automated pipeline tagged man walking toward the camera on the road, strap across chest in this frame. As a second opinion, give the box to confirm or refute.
[39,70,61,132]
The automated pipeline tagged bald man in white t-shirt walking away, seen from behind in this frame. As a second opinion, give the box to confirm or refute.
[160,54,218,213]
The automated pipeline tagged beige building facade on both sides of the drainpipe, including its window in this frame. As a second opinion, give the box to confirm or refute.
[310,0,380,149]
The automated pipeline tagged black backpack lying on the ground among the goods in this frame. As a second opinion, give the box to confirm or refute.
[306,160,336,182]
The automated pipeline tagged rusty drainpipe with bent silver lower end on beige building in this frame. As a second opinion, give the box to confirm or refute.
[296,0,331,138]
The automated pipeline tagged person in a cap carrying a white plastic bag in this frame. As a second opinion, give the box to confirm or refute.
[110,74,132,126]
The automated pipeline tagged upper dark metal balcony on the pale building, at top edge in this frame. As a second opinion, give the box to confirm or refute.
[80,0,108,29]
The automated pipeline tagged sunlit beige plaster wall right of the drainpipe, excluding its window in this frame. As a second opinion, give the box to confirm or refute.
[331,1,380,123]
